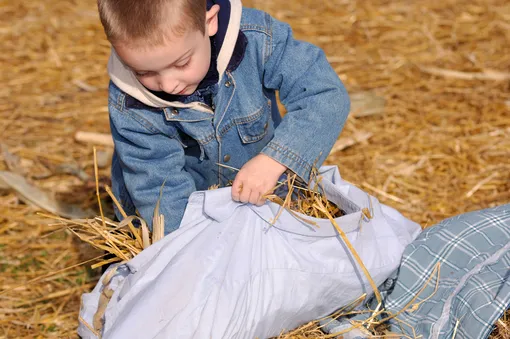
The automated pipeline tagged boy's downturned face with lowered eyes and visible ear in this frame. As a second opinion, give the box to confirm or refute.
[114,5,219,95]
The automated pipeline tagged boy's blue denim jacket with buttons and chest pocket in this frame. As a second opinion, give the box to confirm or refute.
[109,8,349,234]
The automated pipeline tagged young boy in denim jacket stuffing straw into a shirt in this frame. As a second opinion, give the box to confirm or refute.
[98,0,349,234]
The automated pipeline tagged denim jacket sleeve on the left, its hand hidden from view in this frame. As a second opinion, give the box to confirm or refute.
[110,107,196,235]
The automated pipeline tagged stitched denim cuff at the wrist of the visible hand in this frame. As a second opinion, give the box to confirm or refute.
[261,140,312,182]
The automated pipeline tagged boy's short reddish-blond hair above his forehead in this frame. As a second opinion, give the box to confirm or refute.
[97,0,207,46]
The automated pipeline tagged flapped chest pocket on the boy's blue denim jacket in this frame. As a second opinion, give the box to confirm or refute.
[234,105,271,144]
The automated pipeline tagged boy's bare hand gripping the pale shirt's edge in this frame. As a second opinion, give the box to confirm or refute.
[232,154,287,206]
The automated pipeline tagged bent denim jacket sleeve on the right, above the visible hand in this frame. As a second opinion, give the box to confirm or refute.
[262,14,350,181]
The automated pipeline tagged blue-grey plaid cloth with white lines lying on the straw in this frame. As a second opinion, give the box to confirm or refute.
[346,204,510,339]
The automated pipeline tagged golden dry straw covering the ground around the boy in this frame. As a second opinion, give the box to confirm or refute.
[0,0,510,338]
